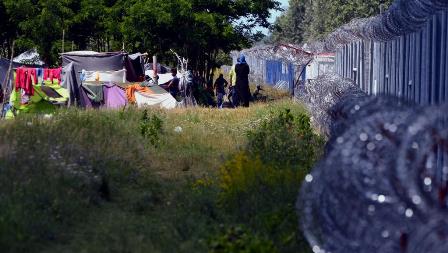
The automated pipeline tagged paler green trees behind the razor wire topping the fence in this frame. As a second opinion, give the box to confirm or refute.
[270,0,392,44]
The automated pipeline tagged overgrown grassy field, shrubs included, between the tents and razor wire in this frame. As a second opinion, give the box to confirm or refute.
[0,88,322,252]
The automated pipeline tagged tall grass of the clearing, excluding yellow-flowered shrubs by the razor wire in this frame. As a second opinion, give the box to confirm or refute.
[0,100,318,252]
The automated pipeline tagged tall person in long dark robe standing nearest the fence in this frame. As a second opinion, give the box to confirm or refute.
[235,54,251,107]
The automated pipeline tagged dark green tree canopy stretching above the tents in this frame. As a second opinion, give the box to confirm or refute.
[0,0,280,72]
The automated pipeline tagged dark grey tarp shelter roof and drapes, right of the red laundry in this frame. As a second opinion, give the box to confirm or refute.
[62,51,144,107]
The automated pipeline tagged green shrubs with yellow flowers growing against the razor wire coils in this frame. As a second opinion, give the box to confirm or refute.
[219,110,323,252]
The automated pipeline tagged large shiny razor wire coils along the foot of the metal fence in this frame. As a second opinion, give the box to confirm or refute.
[296,74,448,253]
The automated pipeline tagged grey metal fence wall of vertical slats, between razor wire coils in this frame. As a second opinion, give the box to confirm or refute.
[336,10,448,105]
